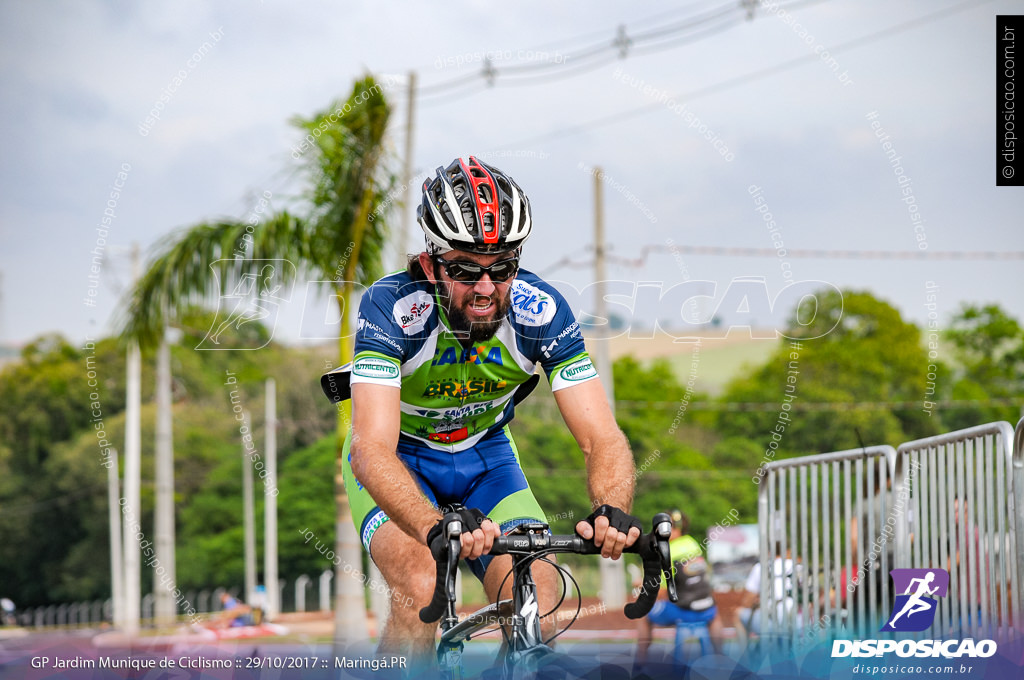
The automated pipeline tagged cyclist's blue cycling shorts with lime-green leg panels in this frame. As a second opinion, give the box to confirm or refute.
[342,426,545,580]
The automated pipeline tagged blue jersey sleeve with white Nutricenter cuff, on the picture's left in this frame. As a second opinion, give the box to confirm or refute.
[350,282,408,388]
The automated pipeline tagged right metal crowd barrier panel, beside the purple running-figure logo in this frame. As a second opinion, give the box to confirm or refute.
[895,419,1024,638]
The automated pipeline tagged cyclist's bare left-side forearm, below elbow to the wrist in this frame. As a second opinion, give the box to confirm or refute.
[352,444,440,543]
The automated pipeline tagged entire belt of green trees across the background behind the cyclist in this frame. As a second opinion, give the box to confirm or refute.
[0,292,1024,607]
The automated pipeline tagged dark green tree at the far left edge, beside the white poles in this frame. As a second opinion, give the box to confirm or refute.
[0,335,118,606]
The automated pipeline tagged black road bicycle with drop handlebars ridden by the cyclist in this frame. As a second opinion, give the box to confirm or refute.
[420,512,677,680]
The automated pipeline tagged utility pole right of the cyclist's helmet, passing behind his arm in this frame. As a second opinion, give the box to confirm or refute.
[591,167,626,608]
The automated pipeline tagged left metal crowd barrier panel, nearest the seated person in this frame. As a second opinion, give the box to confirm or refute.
[758,445,896,641]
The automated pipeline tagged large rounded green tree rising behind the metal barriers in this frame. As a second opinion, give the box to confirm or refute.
[718,291,939,464]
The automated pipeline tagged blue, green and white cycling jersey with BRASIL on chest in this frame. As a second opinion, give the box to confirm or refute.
[327,269,597,452]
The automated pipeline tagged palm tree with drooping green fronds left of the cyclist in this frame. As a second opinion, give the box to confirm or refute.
[121,76,395,642]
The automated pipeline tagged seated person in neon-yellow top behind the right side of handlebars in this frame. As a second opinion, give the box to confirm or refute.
[634,509,722,667]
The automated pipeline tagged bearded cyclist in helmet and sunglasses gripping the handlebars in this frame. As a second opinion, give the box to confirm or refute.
[322,157,640,663]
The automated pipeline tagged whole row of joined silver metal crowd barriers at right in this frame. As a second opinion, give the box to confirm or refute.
[758,419,1024,640]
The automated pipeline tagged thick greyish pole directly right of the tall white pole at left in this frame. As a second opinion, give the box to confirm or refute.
[153,328,178,625]
